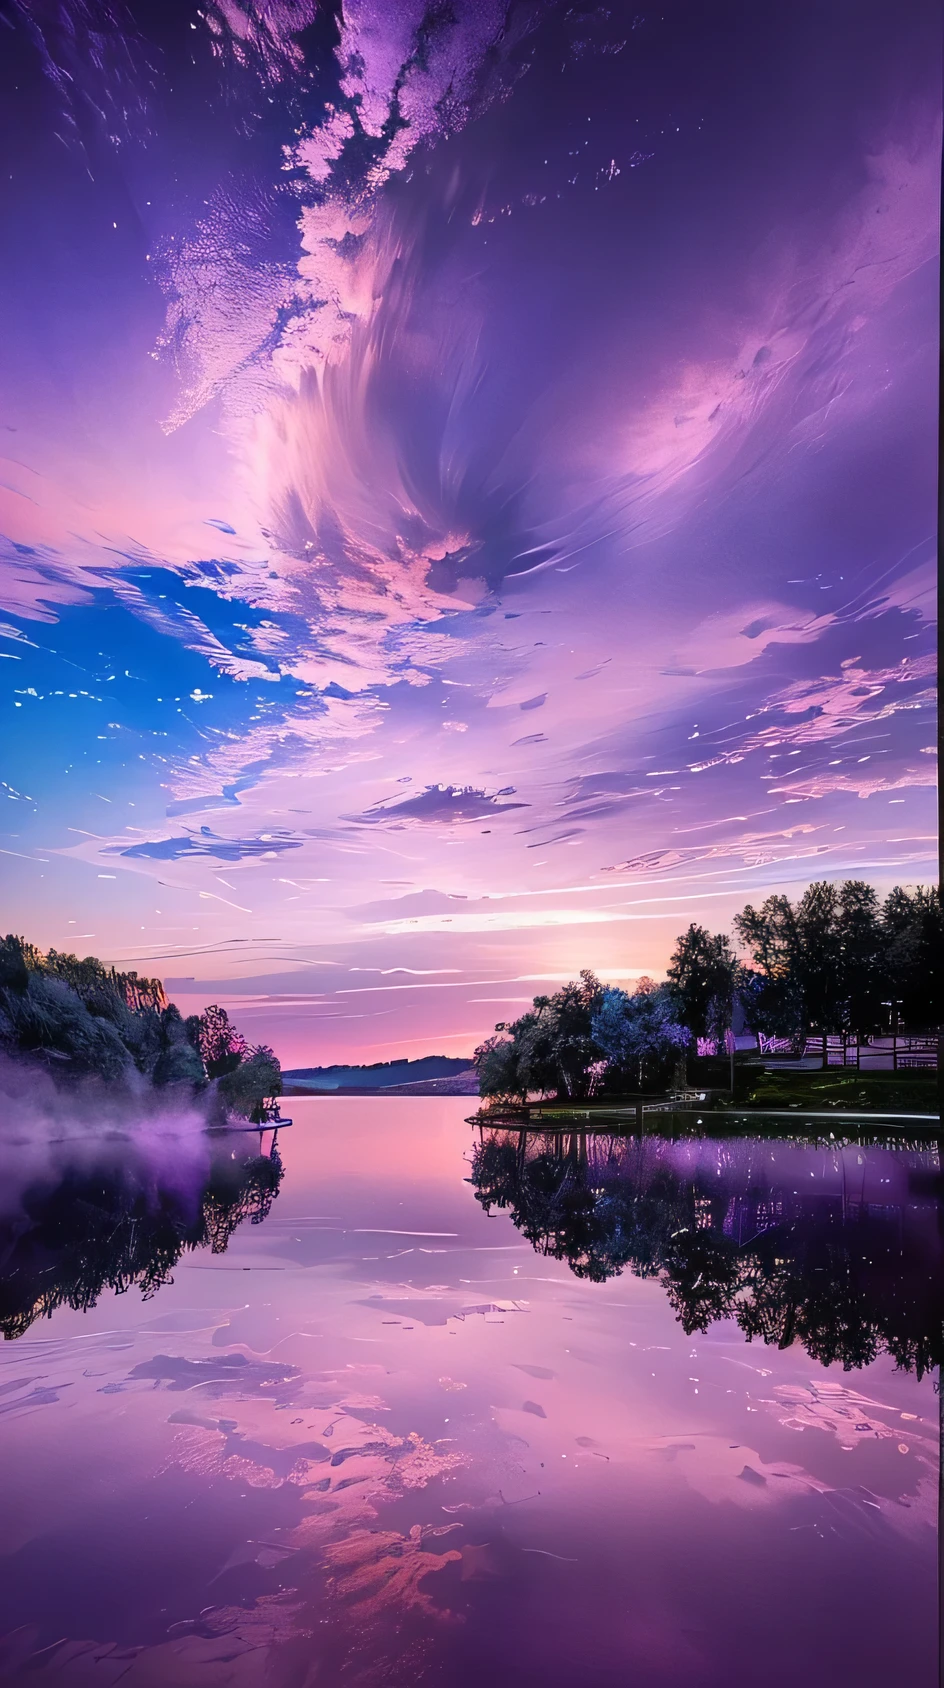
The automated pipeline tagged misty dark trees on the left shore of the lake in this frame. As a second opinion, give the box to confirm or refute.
[0,933,282,1124]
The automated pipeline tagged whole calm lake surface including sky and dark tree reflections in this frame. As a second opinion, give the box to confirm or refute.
[0,1099,942,1688]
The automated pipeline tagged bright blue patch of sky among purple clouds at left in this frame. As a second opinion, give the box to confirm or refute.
[0,571,323,844]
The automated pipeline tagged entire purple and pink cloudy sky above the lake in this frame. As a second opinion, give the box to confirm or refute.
[0,0,941,1063]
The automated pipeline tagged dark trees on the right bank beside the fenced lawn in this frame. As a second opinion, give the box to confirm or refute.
[473,879,944,1102]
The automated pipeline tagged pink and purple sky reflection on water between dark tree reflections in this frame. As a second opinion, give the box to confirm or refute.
[0,1099,937,1688]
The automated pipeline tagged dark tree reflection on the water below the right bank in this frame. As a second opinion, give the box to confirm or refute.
[471,1129,944,1377]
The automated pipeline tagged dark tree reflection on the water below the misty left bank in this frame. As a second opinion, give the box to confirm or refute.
[0,1139,282,1340]
